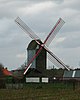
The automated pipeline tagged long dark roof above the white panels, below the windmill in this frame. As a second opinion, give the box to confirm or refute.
[26,68,64,78]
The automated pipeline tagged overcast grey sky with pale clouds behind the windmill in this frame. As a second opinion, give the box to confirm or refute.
[0,0,80,69]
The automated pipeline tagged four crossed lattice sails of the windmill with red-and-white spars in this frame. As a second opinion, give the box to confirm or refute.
[15,17,70,75]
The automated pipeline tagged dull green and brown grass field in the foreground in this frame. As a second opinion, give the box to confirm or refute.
[0,83,80,100]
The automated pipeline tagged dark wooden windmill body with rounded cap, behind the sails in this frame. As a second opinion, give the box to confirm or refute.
[27,40,47,72]
